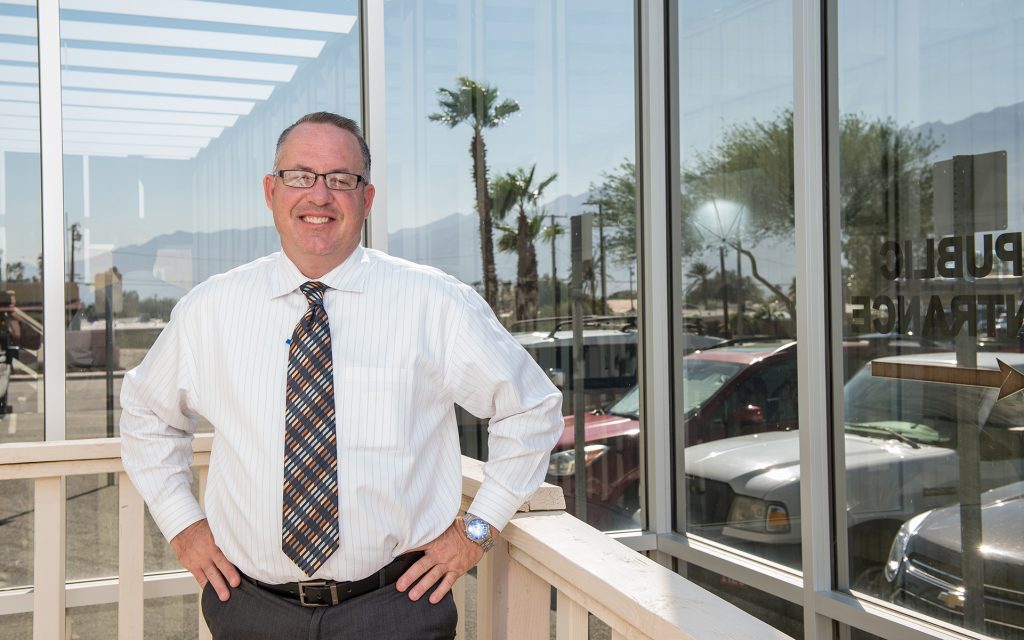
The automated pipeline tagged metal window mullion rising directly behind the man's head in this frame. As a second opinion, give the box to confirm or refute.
[359,0,388,251]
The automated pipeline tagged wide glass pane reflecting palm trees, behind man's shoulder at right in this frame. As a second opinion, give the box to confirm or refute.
[385,0,640,529]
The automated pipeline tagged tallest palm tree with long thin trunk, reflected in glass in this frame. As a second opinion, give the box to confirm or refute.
[429,76,519,308]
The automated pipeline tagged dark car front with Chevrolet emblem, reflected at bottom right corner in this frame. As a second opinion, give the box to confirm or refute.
[885,481,1024,639]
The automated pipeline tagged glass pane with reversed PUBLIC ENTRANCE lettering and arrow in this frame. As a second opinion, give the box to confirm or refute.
[833,0,1024,638]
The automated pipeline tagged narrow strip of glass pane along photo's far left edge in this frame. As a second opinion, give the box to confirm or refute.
[0,2,43,442]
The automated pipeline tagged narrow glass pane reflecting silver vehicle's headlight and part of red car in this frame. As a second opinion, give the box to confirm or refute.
[675,0,800,568]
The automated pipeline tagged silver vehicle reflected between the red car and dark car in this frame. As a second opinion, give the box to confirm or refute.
[685,353,1024,584]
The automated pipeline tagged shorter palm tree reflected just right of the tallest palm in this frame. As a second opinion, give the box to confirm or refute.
[492,164,558,319]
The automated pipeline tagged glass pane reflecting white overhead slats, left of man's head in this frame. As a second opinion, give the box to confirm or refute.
[52,0,361,589]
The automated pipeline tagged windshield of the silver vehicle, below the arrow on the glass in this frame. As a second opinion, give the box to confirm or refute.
[845,365,1024,446]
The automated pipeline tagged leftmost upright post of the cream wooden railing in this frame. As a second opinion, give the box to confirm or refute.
[32,477,68,640]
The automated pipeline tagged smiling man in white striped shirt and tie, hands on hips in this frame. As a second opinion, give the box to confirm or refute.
[121,113,562,639]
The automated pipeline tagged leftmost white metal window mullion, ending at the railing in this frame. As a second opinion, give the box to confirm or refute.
[37,0,67,440]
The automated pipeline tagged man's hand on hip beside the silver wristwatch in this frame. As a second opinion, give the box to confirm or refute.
[395,519,497,604]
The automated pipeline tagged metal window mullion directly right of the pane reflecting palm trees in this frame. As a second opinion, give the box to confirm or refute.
[636,2,679,548]
